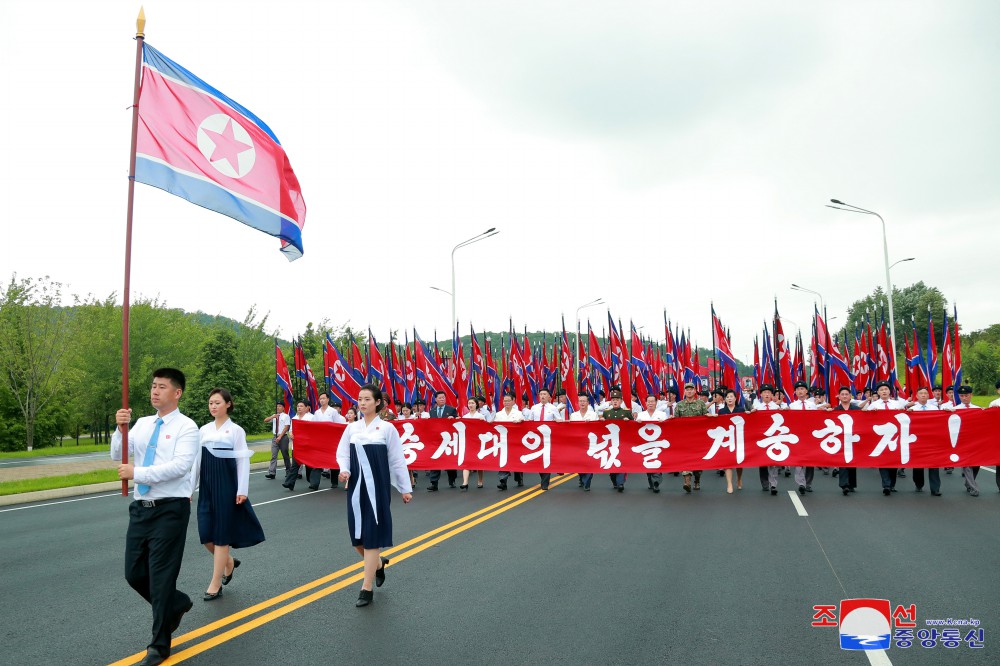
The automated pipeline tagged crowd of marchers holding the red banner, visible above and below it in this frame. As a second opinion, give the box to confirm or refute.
[267,381,1000,497]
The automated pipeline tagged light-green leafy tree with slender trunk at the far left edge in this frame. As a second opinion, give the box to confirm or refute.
[0,275,74,451]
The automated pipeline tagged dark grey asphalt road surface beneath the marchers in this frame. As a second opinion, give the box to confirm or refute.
[0,469,1000,664]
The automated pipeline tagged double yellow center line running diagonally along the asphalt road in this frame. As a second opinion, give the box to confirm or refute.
[109,474,576,666]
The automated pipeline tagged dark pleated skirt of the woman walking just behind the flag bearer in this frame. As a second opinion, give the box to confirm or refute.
[198,448,264,548]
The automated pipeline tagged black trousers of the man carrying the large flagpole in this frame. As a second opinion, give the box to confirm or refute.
[125,497,191,655]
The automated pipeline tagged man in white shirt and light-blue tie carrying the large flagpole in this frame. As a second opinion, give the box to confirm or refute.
[111,368,199,666]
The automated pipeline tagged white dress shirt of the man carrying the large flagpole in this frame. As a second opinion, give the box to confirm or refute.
[111,409,200,499]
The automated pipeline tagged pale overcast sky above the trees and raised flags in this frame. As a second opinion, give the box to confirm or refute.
[0,0,1000,361]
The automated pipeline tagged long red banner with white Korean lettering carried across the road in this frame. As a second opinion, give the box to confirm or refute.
[295,409,1000,472]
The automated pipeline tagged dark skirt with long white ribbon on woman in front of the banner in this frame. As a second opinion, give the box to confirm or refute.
[347,444,392,549]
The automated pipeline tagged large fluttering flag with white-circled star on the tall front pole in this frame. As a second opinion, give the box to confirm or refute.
[135,43,306,261]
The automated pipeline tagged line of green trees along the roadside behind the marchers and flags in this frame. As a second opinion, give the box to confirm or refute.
[0,274,1000,451]
